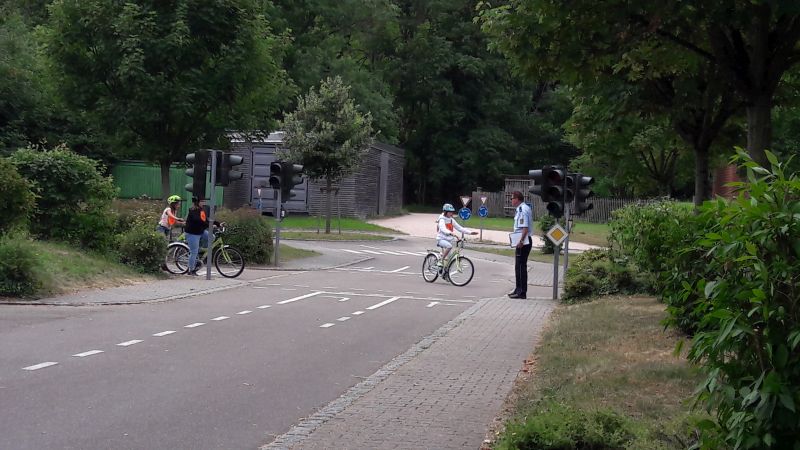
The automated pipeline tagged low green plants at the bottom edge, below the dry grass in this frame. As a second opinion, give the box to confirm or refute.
[495,403,637,450]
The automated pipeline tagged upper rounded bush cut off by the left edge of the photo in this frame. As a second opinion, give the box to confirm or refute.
[0,158,36,235]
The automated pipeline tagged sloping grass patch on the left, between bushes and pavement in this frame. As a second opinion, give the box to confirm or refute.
[33,241,157,295]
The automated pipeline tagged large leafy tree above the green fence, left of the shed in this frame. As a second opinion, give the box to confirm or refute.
[45,0,287,198]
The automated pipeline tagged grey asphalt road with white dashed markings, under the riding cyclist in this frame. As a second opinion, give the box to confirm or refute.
[0,240,536,449]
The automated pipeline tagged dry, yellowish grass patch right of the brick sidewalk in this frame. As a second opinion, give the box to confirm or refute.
[494,297,701,448]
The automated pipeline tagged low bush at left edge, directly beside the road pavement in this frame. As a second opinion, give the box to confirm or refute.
[0,235,42,297]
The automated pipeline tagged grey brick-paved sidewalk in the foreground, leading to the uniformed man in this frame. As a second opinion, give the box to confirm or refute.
[262,298,555,449]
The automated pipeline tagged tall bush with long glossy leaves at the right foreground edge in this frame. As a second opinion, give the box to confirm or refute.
[665,150,800,449]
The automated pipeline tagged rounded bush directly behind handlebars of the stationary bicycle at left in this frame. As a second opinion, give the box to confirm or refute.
[215,208,273,264]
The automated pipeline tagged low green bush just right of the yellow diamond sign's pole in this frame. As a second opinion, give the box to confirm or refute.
[562,249,653,303]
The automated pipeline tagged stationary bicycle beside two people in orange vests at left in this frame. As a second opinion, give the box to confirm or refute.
[164,223,244,278]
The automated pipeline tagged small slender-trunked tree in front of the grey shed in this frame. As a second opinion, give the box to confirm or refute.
[279,77,373,234]
